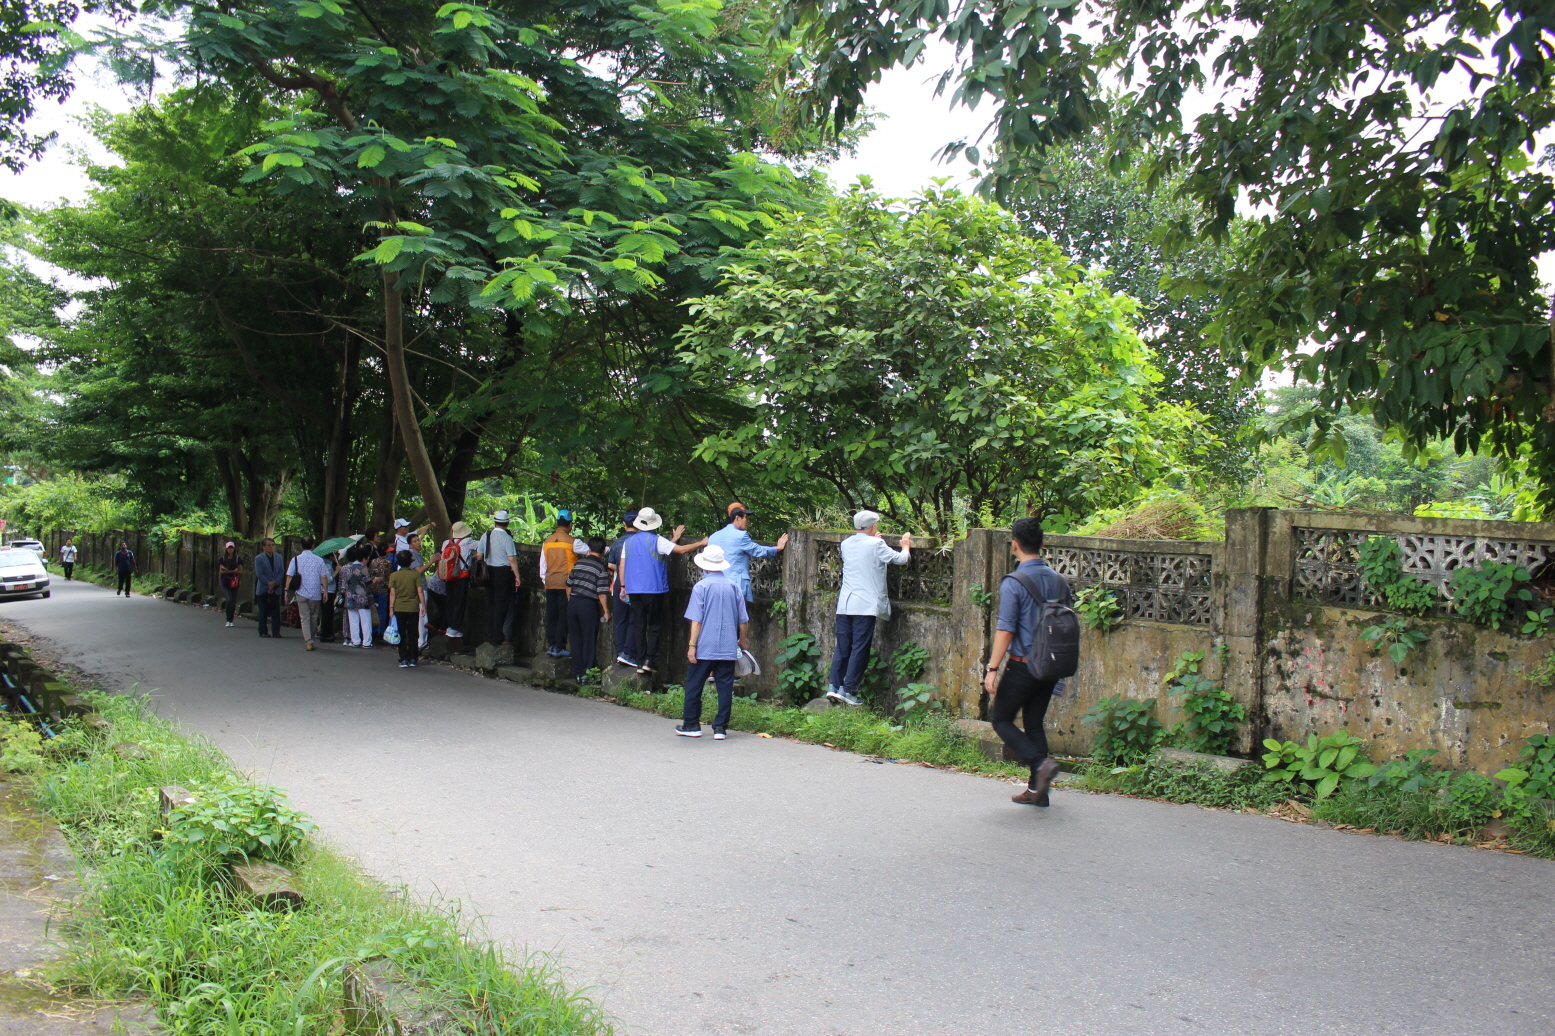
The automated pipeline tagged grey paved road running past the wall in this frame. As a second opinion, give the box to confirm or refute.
[0,582,1555,1036]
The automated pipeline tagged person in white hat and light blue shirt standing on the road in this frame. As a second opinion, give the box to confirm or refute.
[675,543,751,740]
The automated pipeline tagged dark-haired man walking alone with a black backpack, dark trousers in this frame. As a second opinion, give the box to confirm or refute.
[983,518,1079,806]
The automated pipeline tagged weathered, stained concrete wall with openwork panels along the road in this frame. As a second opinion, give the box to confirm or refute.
[45,509,1555,772]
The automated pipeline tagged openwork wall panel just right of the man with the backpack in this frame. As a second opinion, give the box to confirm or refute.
[1032,548,1214,625]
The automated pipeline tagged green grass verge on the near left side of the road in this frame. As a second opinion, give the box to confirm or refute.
[22,694,613,1036]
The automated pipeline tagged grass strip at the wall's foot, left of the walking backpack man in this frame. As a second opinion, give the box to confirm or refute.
[616,688,1028,778]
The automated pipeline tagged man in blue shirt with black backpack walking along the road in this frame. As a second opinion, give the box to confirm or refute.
[983,518,1073,806]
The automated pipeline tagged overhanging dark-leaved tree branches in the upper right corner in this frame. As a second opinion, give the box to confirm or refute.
[787,0,1555,493]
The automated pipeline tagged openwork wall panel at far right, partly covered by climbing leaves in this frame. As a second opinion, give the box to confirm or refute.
[1292,527,1555,614]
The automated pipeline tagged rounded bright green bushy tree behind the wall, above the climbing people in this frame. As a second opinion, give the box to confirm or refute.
[683,188,1211,537]
